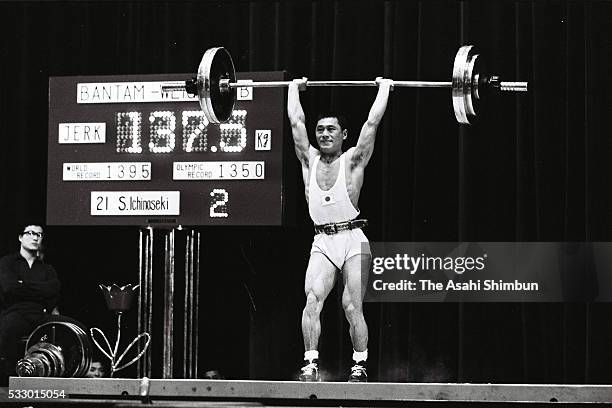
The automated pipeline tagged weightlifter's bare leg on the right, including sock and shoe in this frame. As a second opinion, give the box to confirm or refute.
[342,254,371,381]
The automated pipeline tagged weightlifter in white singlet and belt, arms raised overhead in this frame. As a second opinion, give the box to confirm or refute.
[287,78,393,382]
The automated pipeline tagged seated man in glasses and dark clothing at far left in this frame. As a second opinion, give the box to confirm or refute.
[0,224,60,386]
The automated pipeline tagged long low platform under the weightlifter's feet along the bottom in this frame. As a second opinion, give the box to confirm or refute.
[0,377,612,407]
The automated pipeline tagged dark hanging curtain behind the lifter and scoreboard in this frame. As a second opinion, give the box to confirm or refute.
[0,0,612,383]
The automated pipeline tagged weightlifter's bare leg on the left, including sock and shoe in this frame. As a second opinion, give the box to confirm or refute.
[300,252,336,381]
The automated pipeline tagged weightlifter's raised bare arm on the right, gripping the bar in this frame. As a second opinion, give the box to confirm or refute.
[351,78,393,167]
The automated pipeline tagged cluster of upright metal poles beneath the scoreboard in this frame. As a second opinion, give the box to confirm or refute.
[137,227,200,379]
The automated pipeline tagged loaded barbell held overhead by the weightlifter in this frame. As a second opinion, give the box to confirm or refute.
[162,45,527,124]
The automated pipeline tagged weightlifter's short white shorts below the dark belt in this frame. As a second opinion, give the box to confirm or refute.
[310,228,372,271]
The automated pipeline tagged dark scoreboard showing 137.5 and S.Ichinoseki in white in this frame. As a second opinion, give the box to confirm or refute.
[47,72,286,226]
